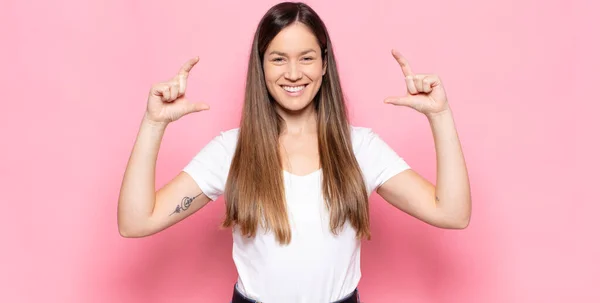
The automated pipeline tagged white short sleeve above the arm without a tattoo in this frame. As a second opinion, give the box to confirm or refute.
[354,128,410,194]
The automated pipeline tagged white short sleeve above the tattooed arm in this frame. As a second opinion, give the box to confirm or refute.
[183,131,237,201]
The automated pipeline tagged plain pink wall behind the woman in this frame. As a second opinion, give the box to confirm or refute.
[0,0,600,303]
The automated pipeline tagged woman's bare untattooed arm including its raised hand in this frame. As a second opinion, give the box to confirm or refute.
[377,50,471,228]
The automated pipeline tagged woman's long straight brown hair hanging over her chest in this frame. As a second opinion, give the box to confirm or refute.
[222,2,370,244]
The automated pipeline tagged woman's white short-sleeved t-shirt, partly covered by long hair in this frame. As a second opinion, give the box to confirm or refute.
[183,126,410,303]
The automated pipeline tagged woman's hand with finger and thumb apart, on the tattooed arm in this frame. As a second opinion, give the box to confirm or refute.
[146,57,210,125]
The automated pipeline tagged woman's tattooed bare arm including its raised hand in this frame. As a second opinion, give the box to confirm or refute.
[117,57,209,237]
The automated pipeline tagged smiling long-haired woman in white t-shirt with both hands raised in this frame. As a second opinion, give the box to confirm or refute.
[118,3,471,303]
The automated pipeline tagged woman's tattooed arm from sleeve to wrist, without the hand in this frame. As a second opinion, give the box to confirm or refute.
[117,118,210,238]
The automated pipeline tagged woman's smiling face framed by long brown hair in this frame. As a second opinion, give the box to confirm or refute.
[263,22,326,111]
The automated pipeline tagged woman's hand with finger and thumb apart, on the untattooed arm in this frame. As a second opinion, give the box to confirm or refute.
[384,50,449,117]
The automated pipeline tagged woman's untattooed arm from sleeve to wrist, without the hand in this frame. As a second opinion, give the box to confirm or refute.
[377,109,471,229]
